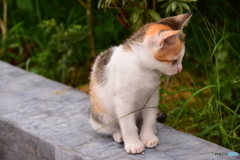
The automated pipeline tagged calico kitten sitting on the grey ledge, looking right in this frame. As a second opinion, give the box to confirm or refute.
[90,12,192,154]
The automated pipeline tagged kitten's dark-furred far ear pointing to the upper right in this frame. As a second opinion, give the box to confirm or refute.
[159,12,193,30]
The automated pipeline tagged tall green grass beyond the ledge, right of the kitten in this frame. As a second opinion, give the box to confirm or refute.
[160,6,240,152]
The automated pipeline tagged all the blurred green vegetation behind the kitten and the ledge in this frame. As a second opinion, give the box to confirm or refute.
[0,0,240,152]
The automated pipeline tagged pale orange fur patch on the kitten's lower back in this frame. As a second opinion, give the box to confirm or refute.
[89,76,105,113]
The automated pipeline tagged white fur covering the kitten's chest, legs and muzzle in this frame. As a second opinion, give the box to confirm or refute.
[90,35,185,154]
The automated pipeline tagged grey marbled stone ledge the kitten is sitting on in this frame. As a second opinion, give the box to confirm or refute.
[0,61,240,160]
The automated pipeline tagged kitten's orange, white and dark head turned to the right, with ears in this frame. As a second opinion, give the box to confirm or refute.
[143,12,192,75]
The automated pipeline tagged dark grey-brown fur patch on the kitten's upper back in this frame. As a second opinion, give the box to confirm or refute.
[95,48,114,84]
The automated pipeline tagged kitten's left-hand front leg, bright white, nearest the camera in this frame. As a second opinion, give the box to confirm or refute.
[115,99,145,154]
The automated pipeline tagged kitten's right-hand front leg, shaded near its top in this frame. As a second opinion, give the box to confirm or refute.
[140,93,159,148]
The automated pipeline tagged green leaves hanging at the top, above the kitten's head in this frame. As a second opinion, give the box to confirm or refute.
[98,0,197,30]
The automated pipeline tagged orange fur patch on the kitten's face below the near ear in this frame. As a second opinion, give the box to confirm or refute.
[154,39,182,62]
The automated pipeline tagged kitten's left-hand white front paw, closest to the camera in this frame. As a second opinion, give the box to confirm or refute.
[125,141,145,154]
